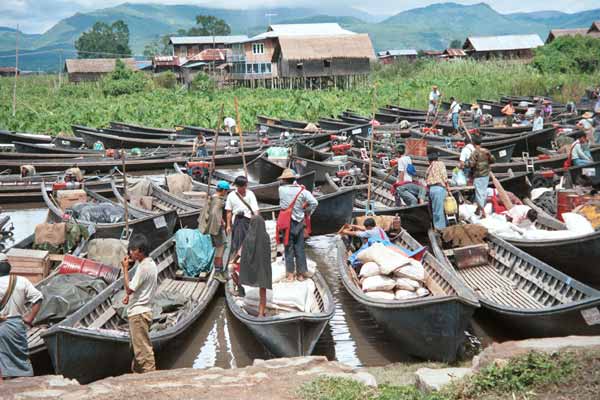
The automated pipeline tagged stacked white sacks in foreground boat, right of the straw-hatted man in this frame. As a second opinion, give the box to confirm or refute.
[357,243,430,300]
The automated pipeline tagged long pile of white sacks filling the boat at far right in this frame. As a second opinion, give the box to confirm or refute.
[459,204,594,240]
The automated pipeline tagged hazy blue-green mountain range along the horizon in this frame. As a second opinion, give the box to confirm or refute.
[0,3,600,71]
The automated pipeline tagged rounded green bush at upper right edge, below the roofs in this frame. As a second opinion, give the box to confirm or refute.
[533,36,600,74]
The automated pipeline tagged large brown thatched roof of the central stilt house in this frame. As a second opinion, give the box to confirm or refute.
[273,34,375,60]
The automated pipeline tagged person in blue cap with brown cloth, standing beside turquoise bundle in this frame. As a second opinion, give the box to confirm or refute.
[198,181,230,282]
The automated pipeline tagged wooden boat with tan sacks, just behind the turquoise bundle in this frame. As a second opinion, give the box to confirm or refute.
[111,181,202,229]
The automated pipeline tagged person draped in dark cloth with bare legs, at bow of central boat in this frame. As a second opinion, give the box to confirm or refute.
[239,214,273,317]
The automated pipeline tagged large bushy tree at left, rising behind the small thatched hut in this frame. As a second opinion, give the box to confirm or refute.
[75,20,131,58]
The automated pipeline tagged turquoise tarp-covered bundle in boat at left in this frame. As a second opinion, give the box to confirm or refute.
[175,229,215,277]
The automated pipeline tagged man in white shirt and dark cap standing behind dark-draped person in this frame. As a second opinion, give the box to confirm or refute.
[225,176,258,258]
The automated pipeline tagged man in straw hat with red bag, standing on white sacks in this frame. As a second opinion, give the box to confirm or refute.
[277,168,319,281]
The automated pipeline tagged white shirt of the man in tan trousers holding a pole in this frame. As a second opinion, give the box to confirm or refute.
[127,257,158,317]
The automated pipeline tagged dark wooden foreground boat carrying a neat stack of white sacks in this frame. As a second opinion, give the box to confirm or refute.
[338,230,479,362]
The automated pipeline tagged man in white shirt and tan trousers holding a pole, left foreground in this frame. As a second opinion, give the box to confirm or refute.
[121,234,158,373]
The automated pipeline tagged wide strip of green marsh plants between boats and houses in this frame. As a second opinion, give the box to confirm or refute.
[0,60,600,134]
